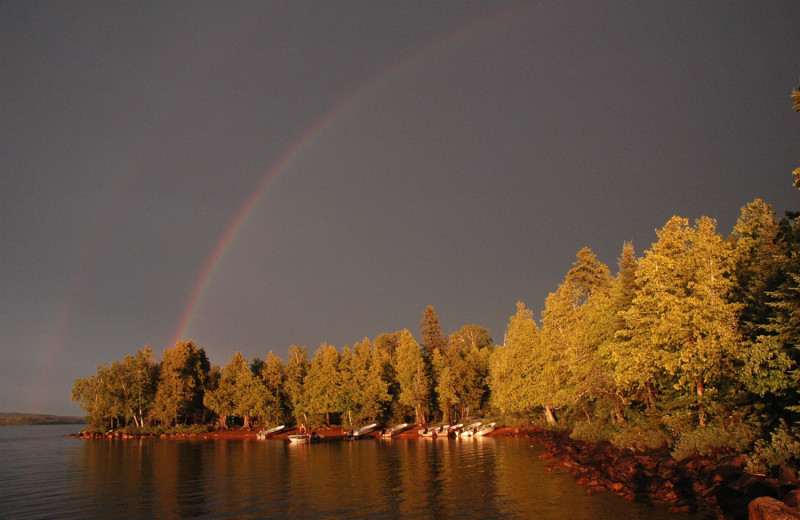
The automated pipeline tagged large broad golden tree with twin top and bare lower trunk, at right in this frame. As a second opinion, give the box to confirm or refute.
[617,217,741,426]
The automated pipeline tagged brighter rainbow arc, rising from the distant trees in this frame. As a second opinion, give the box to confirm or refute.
[171,6,529,345]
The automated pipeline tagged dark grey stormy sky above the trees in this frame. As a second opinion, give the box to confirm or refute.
[0,0,800,414]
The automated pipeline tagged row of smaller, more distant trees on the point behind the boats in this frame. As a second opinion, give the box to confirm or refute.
[72,306,495,430]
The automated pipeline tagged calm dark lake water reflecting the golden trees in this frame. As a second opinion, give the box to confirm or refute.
[0,425,704,520]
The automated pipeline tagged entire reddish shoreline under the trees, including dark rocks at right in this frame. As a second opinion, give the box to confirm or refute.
[66,425,800,520]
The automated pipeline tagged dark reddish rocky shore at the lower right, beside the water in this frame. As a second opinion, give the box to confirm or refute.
[518,431,800,520]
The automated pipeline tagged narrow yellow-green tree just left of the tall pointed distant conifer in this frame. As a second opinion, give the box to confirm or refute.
[393,330,431,424]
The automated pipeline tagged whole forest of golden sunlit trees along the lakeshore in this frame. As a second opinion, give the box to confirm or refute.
[72,86,800,470]
